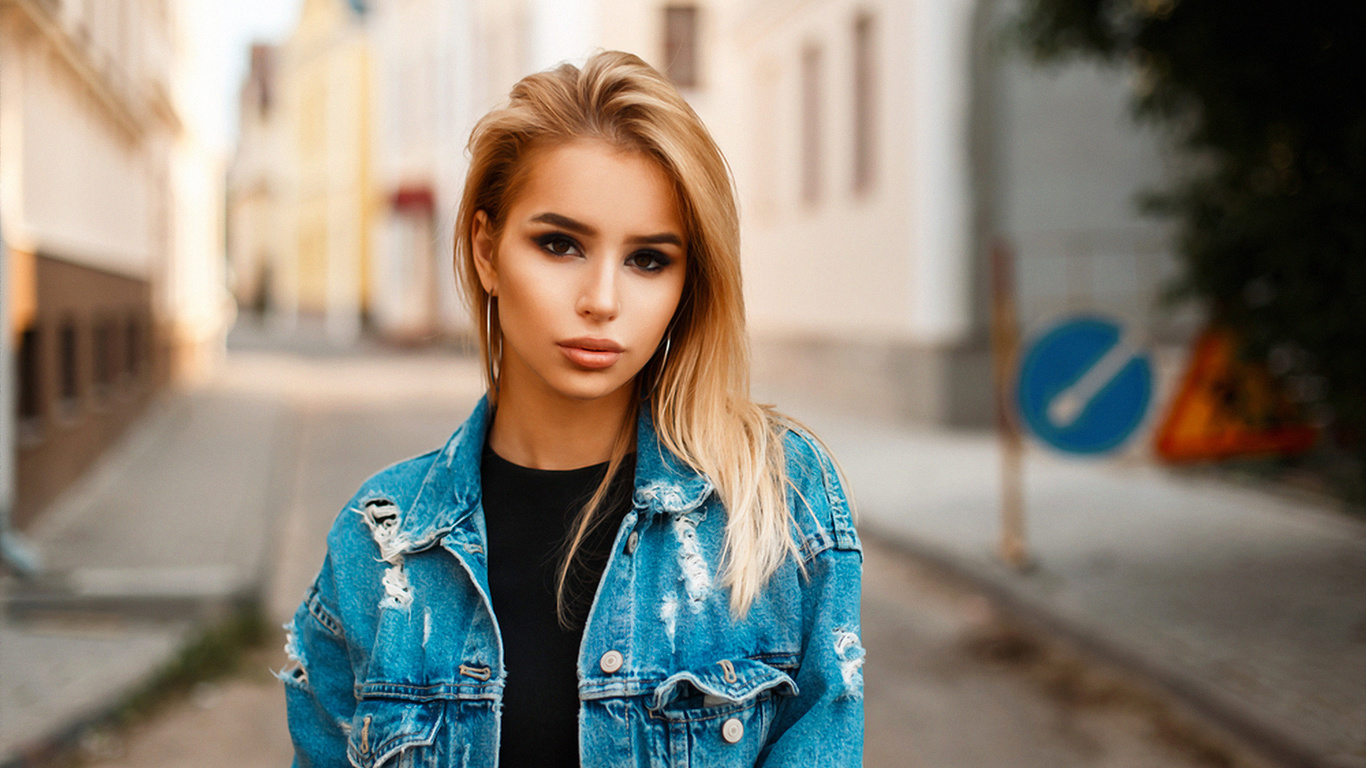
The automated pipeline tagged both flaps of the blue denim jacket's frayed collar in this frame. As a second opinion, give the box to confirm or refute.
[395,395,713,552]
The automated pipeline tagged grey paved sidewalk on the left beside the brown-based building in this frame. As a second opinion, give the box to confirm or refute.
[0,379,287,765]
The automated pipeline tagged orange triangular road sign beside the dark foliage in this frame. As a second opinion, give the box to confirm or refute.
[1157,329,1318,462]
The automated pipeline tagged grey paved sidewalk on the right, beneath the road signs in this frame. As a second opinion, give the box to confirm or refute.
[796,401,1366,767]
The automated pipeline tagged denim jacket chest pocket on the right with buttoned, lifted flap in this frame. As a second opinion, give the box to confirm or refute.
[650,659,798,765]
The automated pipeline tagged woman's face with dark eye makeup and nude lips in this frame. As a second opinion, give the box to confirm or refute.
[473,139,687,403]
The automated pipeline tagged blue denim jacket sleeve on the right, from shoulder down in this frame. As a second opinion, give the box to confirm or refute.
[759,426,863,768]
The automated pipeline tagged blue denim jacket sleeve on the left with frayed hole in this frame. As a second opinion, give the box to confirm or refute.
[279,553,355,768]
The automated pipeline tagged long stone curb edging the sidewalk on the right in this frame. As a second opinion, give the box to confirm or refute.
[862,518,1362,768]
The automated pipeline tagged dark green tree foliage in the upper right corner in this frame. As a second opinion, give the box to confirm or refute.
[1019,0,1366,466]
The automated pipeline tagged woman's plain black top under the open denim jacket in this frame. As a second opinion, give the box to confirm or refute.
[479,445,635,768]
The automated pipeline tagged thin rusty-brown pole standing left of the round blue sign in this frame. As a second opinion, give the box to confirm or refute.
[990,239,1030,571]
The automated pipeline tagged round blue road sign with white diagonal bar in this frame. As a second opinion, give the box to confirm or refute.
[1015,317,1153,454]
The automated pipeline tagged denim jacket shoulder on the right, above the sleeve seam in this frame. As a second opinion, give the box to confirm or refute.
[780,417,862,559]
